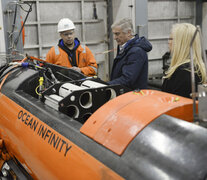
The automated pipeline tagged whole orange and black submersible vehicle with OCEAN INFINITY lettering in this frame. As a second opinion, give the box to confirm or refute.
[0,57,207,180]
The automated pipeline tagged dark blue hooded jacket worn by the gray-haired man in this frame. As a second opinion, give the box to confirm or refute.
[108,35,152,90]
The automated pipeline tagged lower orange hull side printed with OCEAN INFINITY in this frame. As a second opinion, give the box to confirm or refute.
[0,94,123,180]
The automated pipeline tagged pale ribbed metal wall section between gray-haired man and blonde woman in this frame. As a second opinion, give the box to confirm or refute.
[148,0,195,76]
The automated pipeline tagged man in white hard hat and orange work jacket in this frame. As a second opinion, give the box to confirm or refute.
[46,18,97,76]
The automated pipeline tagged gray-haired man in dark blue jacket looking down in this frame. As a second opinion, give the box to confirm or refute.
[108,18,152,90]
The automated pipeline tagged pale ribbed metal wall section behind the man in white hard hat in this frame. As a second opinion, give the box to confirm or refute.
[22,0,108,80]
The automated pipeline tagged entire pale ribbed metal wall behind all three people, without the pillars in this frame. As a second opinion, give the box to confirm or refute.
[22,0,195,80]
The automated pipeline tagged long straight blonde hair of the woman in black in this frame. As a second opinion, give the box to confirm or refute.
[164,23,206,83]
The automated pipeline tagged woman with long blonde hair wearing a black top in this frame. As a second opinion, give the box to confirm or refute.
[162,23,206,98]
